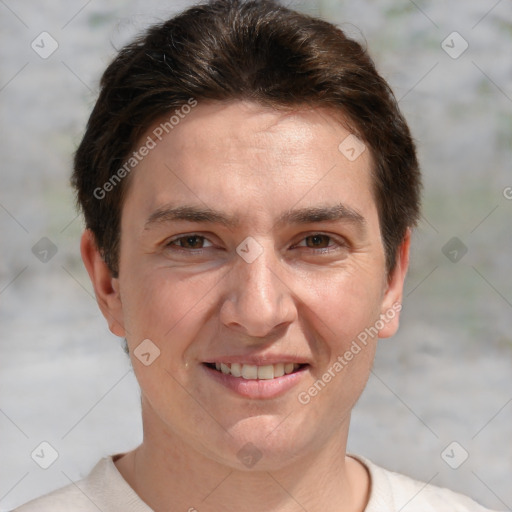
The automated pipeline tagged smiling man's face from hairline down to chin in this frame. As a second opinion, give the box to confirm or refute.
[104,102,405,469]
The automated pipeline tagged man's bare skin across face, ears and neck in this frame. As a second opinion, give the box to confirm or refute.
[82,101,410,512]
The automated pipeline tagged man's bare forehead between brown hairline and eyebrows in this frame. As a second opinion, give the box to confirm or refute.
[121,101,375,226]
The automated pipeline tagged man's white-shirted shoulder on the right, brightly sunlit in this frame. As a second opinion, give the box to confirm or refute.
[355,457,500,512]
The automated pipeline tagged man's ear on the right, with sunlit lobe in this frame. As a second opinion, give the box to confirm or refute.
[379,228,411,338]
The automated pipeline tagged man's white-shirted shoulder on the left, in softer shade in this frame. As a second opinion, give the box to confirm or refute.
[13,457,151,512]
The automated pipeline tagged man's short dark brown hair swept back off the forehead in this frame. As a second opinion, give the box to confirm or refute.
[72,0,421,276]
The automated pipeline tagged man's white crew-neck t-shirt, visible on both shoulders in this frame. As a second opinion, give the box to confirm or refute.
[13,457,500,512]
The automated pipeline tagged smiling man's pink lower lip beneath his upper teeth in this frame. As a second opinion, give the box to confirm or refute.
[201,364,307,400]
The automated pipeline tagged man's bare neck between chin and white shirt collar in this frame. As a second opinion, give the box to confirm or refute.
[116,406,369,512]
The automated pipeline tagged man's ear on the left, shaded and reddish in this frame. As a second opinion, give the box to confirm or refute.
[80,229,125,337]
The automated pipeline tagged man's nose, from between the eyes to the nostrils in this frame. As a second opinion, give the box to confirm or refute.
[220,244,297,338]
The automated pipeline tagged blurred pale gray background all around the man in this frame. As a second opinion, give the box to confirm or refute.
[0,0,512,511]
